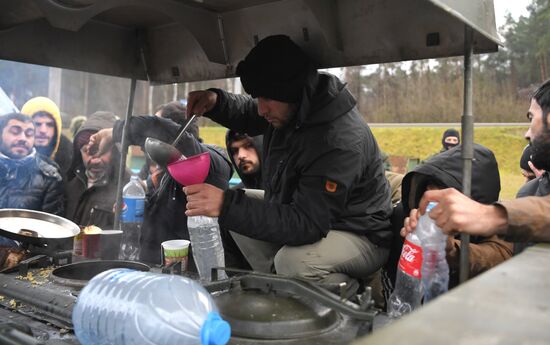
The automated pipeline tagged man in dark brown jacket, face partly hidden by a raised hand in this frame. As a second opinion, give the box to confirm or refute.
[65,111,129,229]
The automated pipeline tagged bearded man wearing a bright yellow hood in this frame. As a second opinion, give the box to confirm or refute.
[21,97,73,180]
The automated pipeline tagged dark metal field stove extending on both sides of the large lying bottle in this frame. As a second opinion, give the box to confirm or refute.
[0,262,376,345]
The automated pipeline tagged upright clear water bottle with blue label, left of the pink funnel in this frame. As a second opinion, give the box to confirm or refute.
[119,176,145,261]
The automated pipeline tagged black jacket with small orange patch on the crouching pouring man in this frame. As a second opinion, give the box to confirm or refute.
[207,73,391,245]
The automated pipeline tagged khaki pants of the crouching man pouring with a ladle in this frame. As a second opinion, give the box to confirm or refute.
[230,189,389,284]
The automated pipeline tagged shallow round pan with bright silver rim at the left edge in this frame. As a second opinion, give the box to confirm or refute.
[0,208,80,247]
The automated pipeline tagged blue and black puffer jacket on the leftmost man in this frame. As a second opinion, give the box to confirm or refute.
[0,153,63,216]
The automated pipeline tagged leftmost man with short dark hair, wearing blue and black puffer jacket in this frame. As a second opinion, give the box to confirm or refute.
[0,113,63,215]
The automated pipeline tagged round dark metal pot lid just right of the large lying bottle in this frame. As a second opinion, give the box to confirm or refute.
[215,289,340,339]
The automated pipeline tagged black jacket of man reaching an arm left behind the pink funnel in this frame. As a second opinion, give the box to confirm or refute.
[113,116,233,263]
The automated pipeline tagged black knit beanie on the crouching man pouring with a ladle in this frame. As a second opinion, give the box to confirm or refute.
[237,35,315,103]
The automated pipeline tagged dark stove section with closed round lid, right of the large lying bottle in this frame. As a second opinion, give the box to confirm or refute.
[205,272,376,345]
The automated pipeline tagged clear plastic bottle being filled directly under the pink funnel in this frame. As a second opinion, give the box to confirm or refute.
[187,216,227,282]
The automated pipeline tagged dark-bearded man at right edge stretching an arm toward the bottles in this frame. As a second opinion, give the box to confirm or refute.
[401,80,550,242]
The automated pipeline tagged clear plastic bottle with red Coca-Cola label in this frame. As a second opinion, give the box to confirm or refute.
[388,222,422,319]
